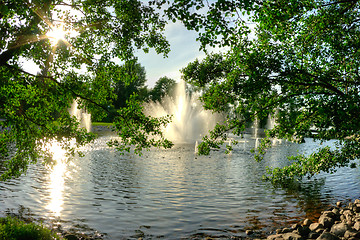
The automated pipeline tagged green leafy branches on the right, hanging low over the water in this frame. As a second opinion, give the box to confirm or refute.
[183,0,360,182]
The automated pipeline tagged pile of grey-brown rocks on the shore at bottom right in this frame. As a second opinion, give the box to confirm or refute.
[267,199,360,240]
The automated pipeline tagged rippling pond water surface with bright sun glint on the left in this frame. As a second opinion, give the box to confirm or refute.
[0,137,360,239]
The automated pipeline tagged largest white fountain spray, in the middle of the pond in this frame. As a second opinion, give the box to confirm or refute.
[145,81,222,143]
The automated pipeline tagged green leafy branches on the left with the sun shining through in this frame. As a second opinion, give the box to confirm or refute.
[0,0,171,179]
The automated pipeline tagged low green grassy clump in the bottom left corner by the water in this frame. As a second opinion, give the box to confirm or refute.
[0,217,61,240]
